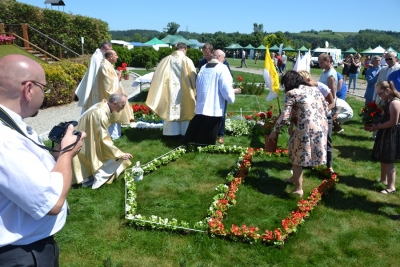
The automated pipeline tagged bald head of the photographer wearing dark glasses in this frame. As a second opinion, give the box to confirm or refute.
[0,54,46,118]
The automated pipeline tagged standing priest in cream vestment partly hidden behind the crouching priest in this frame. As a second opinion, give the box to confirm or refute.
[84,50,134,140]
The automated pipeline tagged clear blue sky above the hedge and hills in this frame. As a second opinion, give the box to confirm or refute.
[17,0,400,33]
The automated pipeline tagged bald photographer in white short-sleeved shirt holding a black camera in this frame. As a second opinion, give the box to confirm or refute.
[0,55,86,266]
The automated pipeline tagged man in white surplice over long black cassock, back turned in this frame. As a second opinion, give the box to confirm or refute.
[183,50,240,145]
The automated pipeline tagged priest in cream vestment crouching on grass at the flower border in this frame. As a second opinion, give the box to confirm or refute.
[72,92,132,189]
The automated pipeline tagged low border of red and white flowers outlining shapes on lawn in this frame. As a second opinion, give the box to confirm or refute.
[125,145,338,246]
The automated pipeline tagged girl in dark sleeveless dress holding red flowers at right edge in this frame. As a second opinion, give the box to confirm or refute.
[368,81,400,194]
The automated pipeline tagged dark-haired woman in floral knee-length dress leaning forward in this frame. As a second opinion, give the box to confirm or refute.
[269,71,328,199]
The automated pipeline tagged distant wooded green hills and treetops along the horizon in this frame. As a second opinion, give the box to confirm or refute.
[109,22,400,52]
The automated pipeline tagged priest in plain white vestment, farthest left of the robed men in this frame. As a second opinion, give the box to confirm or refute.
[75,42,112,113]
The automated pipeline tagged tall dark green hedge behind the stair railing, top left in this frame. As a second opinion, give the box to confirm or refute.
[0,0,111,58]
